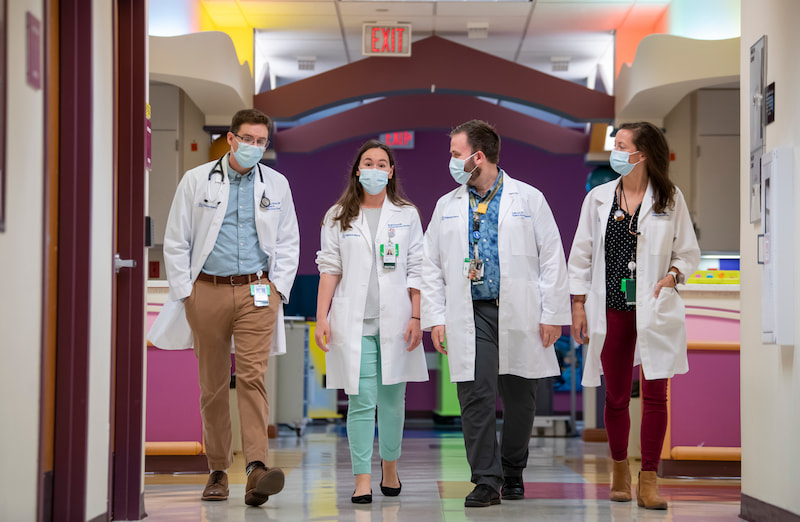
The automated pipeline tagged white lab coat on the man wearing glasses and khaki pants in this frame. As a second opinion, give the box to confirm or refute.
[148,153,300,355]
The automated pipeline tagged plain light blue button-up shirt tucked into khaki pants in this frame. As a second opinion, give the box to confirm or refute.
[203,159,269,276]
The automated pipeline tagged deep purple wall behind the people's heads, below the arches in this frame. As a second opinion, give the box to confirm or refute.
[273,129,592,274]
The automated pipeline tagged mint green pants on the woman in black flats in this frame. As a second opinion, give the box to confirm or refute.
[347,335,406,475]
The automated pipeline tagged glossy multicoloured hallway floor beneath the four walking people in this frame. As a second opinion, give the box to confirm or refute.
[145,423,740,522]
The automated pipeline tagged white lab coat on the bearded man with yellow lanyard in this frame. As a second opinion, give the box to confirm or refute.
[422,174,571,382]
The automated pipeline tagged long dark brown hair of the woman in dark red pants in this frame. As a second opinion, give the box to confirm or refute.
[619,121,675,214]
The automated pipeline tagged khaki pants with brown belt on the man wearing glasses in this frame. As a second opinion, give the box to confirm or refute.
[184,279,281,471]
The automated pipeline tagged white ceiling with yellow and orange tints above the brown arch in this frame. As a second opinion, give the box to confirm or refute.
[200,0,671,93]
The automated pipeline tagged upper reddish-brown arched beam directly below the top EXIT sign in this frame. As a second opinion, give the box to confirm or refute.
[253,36,614,122]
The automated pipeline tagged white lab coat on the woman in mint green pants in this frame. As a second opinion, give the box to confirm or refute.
[317,197,428,395]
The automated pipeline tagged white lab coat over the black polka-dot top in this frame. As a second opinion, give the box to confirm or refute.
[569,180,700,386]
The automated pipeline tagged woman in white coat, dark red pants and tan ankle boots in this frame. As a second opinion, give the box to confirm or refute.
[568,122,700,509]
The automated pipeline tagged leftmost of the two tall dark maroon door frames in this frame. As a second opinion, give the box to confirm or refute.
[51,0,94,520]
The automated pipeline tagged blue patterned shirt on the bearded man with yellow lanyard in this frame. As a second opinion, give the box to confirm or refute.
[467,170,503,300]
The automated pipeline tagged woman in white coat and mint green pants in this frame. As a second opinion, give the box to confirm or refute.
[315,140,428,504]
